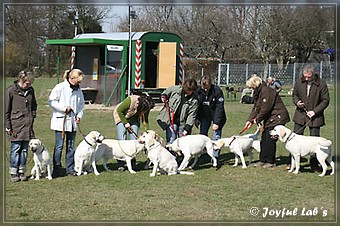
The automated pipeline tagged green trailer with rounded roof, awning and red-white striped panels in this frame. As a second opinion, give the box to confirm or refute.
[46,32,183,106]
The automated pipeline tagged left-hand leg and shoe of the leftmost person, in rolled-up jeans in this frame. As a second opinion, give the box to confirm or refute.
[9,141,21,182]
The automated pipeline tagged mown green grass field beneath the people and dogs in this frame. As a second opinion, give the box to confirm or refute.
[3,79,337,223]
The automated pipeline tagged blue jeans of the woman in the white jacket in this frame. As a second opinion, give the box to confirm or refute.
[53,131,77,176]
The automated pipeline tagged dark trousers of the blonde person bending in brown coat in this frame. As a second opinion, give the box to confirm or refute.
[260,126,277,164]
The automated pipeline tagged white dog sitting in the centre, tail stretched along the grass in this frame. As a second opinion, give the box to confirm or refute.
[139,131,194,177]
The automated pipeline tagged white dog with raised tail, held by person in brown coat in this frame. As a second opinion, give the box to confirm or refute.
[214,127,261,168]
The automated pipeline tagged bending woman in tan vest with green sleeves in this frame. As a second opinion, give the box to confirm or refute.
[113,93,155,172]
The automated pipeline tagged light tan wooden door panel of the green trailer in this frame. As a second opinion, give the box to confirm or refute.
[157,42,177,88]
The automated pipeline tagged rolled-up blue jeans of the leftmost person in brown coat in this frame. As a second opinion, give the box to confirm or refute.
[9,141,29,174]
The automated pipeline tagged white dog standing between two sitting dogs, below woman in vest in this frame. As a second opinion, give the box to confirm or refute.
[95,139,144,173]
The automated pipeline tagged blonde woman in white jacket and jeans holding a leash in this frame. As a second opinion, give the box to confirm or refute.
[48,69,85,177]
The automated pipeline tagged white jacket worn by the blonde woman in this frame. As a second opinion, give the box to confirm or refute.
[48,80,85,132]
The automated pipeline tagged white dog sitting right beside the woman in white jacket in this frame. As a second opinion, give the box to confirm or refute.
[74,131,104,176]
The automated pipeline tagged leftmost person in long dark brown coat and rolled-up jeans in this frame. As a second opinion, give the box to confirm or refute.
[5,71,37,182]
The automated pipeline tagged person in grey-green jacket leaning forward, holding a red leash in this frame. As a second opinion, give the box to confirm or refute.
[157,78,198,143]
